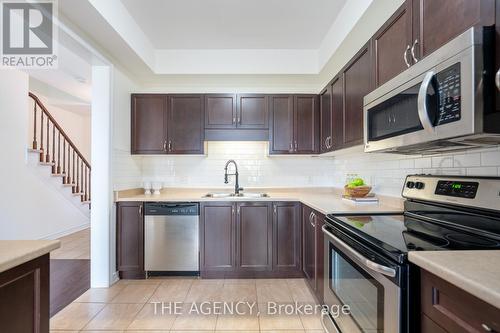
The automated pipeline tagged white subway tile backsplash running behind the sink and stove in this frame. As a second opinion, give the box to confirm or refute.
[113,142,500,196]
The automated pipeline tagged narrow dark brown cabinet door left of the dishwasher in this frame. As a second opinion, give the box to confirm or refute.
[116,202,145,279]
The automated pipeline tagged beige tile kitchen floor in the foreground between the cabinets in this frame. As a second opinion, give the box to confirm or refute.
[50,278,323,333]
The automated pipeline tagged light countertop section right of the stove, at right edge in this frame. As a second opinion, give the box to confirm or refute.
[408,251,500,309]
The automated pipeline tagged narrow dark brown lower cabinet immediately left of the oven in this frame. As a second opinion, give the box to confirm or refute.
[302,205,325,302]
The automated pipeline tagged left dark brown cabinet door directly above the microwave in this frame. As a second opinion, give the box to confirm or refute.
[372,0,413,87]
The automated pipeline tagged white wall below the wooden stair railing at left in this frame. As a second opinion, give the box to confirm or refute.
[0,70,89,239]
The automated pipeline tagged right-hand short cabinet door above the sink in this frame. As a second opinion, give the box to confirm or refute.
[236,94,269,129]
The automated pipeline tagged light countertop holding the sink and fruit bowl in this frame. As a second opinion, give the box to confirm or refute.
[115,188,403,214]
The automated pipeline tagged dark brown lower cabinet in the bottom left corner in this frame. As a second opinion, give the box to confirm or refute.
[0,254,50,333]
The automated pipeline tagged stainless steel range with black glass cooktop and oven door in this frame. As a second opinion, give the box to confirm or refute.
[322,175,500,333]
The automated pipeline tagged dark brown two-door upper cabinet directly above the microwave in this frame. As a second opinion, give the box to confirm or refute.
[372,0,495,87]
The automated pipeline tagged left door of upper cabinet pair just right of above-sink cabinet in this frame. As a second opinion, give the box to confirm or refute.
[269,95,294,154]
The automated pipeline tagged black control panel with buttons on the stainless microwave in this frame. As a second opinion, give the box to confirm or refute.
[436,63,461,125]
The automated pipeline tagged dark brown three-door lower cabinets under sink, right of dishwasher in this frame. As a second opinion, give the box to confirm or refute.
[200,202,302,278]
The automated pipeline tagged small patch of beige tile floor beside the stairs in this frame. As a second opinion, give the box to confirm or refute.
[50,228,90,259]
